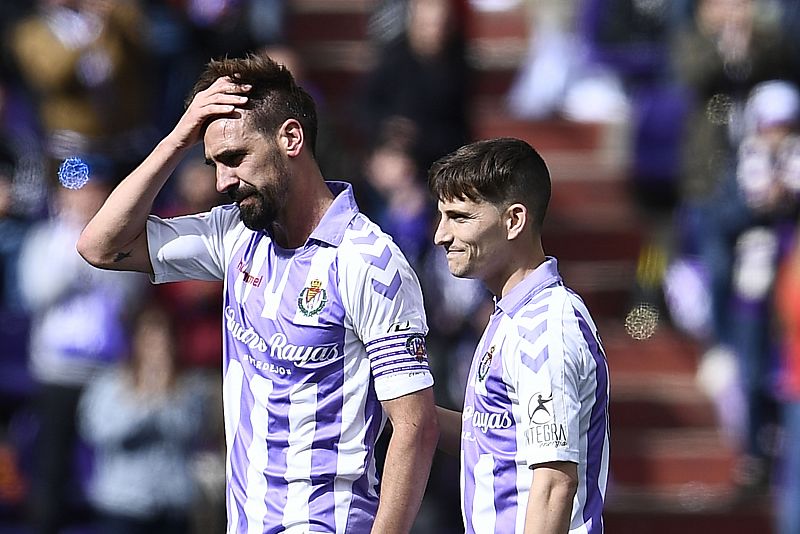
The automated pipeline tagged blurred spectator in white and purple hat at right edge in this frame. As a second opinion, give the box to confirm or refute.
[732,81,800,490]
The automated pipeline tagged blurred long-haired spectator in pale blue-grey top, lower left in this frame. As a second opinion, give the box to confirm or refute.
[79,304,203,534]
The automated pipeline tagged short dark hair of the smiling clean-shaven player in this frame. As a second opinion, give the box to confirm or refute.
[428,137,550,230]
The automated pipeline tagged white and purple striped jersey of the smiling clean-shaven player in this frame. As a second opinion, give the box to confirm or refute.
[461,258,609,534]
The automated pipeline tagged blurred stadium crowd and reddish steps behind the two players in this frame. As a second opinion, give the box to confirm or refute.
[0,0,800,534]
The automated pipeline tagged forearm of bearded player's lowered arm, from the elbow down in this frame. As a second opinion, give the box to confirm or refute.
[372,417,439,534]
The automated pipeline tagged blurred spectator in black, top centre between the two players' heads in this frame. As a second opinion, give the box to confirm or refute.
[355,0,470,173]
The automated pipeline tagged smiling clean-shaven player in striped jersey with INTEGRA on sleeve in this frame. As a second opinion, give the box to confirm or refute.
[429,139,608,534]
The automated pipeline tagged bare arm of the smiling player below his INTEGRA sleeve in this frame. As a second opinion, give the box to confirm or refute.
[525,462,578,534]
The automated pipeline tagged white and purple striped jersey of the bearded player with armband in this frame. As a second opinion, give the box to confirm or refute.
[147,182,433,534]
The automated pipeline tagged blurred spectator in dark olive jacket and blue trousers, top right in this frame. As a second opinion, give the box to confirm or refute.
[672,0,793,360]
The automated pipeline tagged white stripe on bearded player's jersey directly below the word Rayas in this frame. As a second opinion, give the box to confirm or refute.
[283,384,317,532]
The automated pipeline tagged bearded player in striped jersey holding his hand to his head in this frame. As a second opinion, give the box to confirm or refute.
[78,52,438,534]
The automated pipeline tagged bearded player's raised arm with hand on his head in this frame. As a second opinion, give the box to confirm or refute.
[77,78,249,274]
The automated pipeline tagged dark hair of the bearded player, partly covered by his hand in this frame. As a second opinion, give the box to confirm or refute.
[191,54,317,156]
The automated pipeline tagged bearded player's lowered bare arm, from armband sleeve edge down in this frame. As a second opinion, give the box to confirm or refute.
[372,388,439,534]
